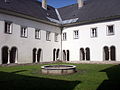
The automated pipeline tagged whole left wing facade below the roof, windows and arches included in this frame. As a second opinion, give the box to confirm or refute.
[0,14,61,64]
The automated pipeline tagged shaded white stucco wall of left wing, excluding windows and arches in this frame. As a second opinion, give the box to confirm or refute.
[0,14,61,64]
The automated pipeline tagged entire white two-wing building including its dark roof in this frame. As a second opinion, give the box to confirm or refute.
[0,0,120,64]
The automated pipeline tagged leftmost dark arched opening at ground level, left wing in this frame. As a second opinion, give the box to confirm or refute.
[2,46,9,64]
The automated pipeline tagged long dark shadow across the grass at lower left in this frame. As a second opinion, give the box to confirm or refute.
[0,70,81,90]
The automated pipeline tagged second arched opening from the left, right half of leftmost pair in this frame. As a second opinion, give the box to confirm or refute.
[10,47,17,63]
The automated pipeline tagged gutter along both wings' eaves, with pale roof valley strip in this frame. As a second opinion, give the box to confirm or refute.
[0,9,120,28]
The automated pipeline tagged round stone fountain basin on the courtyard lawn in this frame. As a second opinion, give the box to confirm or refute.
[41,65,76,75]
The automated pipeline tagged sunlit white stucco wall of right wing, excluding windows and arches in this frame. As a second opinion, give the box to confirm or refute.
[62,20,120,61]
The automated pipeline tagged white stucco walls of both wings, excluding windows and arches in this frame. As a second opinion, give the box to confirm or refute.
[0,14,120,64]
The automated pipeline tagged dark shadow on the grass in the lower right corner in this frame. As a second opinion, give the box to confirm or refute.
[97,65,120,90]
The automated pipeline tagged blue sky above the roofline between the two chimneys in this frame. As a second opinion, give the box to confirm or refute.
[39,0,77,8]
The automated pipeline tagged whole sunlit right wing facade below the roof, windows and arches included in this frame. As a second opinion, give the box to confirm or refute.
[62,20,120,61]
